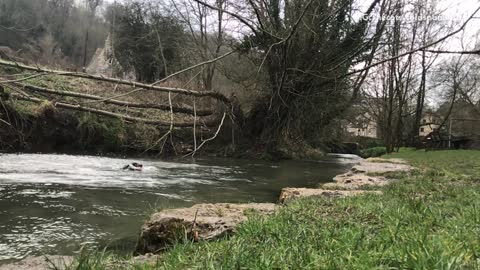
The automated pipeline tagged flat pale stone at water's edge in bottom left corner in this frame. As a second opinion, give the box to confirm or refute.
[0,255,73,270]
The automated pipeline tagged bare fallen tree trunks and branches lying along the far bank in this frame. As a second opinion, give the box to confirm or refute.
[0,51,233,155]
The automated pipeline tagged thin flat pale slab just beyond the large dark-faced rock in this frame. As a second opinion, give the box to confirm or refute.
[279,188,381,203]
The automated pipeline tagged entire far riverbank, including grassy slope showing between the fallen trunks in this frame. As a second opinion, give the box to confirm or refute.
[0,67,344,161]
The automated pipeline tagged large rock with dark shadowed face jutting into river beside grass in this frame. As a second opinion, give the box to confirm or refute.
[136,203,276,254]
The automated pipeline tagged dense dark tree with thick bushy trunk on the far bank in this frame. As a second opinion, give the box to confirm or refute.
[240,0,381,149]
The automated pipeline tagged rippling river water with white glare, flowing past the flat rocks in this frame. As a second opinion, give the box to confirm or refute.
[0,154,358,264]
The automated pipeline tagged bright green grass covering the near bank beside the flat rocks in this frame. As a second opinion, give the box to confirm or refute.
[66,150,480,269]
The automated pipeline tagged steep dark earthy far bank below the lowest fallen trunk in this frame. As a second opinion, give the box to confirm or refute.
[0,98,328,161]
